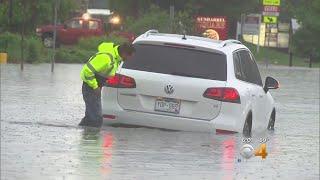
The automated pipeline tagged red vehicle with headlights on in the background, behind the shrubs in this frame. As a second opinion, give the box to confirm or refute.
[36,17,135,48]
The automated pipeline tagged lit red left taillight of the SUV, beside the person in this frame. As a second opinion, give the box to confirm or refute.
[107,74,136,88]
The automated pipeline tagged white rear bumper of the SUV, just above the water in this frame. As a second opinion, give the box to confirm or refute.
[102,88,241,133]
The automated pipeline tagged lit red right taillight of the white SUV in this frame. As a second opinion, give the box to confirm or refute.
[203,87,240,103]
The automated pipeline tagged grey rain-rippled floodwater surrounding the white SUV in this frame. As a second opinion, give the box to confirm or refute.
[1,64,319,180]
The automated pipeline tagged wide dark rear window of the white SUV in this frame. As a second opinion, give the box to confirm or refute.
[122,44,227,81]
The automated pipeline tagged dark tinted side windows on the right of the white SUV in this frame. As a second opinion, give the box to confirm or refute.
[238,50,262,86]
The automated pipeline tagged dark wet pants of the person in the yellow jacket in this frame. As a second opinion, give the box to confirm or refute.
[79,82,102,127]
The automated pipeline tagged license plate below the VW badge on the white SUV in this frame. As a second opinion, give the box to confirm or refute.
[154,98,181,114]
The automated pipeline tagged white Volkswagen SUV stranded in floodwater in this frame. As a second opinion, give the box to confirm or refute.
[102,30,279,135]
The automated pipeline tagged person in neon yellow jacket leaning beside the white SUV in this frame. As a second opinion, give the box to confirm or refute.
[79,42,135,127]
